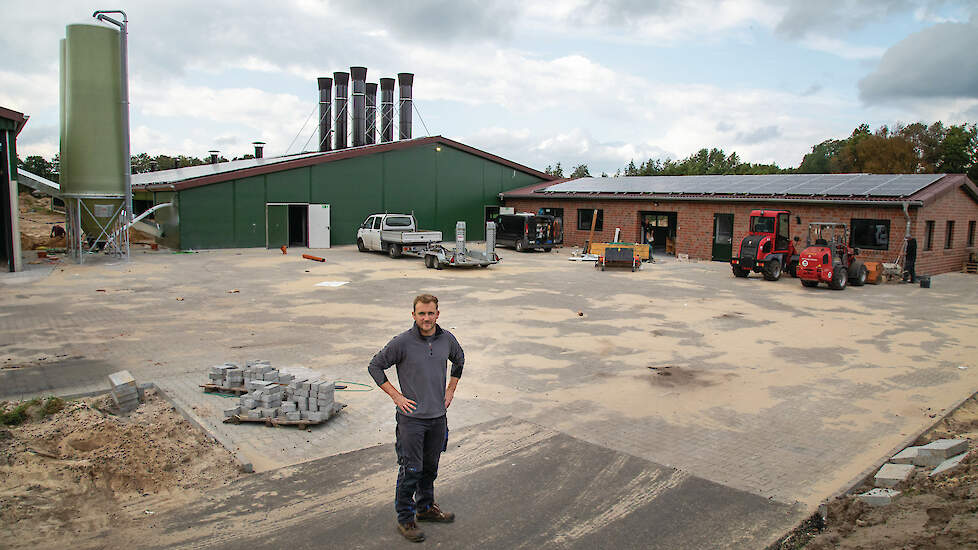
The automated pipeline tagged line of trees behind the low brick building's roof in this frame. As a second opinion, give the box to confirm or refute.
[546,121,978,182]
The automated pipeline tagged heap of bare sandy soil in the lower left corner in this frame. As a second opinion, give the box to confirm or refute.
[0,390,241,548]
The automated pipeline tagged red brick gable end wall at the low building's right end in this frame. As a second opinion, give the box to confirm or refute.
[914,187,978,275]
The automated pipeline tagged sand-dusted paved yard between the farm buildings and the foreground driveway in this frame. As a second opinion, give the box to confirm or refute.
[0,246,978,548]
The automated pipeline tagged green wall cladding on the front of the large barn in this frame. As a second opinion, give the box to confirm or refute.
[172,144,541,249]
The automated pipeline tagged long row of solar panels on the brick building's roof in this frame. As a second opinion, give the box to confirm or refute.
[540,174,945,197]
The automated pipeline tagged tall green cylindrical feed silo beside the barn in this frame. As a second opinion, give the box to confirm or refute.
[60,24,128,240]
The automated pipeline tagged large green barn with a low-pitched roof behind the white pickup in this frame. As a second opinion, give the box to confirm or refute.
[132,136,553,250]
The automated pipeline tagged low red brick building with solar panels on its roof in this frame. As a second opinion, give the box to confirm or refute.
[500,174,978,274]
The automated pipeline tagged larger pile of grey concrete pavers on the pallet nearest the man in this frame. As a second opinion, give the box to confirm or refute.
[212,360,336,423]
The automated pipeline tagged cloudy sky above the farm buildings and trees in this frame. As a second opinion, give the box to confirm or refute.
[0,0,978,175]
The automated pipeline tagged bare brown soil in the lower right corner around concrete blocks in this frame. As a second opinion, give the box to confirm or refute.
[775,395,978,550]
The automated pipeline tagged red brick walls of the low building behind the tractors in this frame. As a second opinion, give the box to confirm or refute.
[505,196,978,274]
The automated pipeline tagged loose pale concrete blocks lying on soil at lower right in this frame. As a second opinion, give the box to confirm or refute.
[857,439,969,506]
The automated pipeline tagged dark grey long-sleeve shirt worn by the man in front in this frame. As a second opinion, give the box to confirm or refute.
[367,324,465,418]
